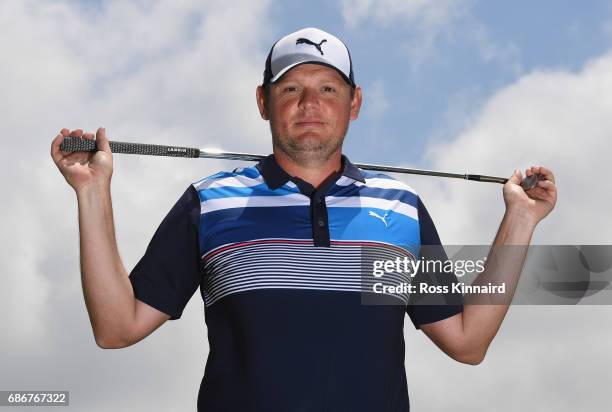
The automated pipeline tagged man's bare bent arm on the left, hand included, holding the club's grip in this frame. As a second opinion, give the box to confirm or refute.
[51,128,170,348]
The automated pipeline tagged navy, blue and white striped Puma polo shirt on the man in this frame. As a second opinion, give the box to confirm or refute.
[130,155,463,411]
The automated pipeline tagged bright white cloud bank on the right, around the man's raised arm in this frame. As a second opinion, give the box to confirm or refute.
[402,45,612,411]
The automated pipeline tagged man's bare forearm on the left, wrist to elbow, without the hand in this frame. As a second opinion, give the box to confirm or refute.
[77,185,136,346]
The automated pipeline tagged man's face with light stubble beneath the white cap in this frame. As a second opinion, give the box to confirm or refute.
[257,64,361,165]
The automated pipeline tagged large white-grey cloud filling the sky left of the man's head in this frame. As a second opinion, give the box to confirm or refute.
[0,0,274,411]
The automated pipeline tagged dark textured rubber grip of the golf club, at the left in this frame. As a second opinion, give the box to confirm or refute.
[60,137,200,158]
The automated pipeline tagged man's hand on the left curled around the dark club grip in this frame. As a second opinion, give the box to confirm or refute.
[51,127,113,192]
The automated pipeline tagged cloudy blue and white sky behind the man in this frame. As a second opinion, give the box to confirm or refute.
[0,0,612,411]
